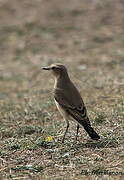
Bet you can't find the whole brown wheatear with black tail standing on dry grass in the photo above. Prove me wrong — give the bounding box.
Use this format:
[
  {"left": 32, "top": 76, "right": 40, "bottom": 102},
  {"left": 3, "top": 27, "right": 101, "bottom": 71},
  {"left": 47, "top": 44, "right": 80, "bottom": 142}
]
[{"left": 42, "top": 63, "right": 100, "bottom": 142}]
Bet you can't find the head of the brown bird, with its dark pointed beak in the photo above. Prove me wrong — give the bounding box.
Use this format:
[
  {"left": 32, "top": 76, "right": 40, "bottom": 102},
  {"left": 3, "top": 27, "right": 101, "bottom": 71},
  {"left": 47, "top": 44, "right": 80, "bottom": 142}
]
[{"left": 42, "top": 63, "right": 67, "bottom": 77}]
